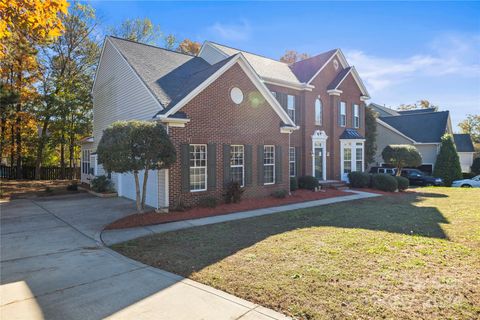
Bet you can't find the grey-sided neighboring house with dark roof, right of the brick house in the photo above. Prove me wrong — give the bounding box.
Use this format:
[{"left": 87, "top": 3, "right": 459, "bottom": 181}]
[{"left": 369, "top": 103, "right": 473, "bottom": 173}]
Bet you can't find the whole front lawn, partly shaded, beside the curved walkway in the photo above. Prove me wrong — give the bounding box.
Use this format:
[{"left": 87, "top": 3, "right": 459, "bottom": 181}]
[{"left": 113, "top": 188, "right": 480, "bottom": 319}]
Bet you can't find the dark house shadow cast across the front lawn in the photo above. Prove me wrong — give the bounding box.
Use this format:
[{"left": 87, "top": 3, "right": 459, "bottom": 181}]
[{"left": 113, "top": 193, "right": 448, "bottom": 276}]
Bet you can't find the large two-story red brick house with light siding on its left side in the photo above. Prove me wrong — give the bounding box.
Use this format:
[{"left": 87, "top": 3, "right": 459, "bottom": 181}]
[{"left": 82, "top": 37, "right": 369, "bottom": 208}]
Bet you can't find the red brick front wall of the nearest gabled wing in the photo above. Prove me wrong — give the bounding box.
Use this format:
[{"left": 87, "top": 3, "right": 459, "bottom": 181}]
[{"left": 169, "top": 64, "right": 289, "bottom": 206}]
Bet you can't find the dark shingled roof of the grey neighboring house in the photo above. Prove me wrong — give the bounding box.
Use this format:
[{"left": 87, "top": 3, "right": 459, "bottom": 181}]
[{"left": 379, "top": 111, "right": 449, "bottom": 143}]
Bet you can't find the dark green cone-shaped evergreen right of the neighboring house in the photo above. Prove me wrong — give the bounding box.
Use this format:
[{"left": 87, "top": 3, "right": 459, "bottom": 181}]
[{"left": 433, "top": 134, "right": 463, "bottom": 187}]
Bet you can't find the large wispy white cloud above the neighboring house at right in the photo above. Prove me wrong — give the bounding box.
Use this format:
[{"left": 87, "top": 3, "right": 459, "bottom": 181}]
[{"left": 345, "top": 34, "right": 480, "bottom": 94}]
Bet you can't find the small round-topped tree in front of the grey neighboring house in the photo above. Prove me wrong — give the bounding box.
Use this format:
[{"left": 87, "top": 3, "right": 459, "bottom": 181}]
[{"left": 382, "top": 144, "right": 422, "bottom": 176}]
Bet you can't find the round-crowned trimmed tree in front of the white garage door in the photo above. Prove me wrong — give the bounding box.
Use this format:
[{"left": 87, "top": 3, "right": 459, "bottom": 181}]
[{"left": 97, "top": 121, "right": 176, "bottom": 212}]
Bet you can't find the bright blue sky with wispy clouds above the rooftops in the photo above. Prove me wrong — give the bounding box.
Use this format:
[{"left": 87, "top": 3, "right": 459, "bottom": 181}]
[{"left": 88, "top": 1, "right": 480, "bottom": 130}]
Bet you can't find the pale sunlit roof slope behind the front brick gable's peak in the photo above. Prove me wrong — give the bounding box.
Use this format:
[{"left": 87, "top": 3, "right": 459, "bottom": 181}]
[{"left": 206, "top": 41, "right": 302, "bottom": 85}]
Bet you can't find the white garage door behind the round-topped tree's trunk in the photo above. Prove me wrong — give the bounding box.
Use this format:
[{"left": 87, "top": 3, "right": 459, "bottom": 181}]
[{"left": 117, "top": 170, "right": 159, "bottom": 208}]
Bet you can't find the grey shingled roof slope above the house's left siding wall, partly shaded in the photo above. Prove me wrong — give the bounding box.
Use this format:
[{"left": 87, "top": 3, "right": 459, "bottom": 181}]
[{"left": 107, "top": 36, "right": 211, "bottom": 108}]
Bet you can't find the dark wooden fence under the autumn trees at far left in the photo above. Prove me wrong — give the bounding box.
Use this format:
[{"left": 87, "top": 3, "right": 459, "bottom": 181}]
[{"left": 0, "top": 166, "right": 80, "bottom": 180}]
